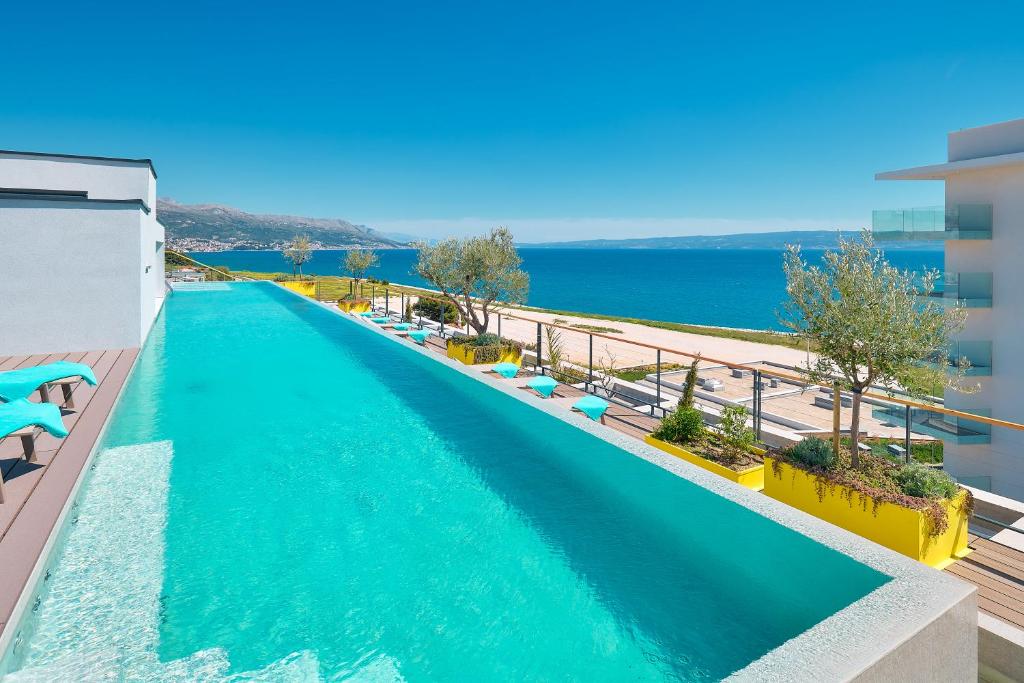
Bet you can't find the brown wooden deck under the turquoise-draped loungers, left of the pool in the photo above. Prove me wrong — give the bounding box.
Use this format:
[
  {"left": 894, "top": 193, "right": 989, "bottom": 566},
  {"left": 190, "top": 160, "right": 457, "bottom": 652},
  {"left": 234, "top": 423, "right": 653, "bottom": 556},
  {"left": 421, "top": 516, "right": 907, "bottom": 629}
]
[{"left": 0, "top": 349, "right": 138, "bottom": 632}]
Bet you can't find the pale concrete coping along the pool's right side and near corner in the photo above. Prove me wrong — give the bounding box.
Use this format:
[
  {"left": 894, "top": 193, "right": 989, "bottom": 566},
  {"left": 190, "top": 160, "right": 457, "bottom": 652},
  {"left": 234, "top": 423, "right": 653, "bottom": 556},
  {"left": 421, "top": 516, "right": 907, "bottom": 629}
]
[{"left": 299, "top": 286, "right": 978, "bottom": 681}]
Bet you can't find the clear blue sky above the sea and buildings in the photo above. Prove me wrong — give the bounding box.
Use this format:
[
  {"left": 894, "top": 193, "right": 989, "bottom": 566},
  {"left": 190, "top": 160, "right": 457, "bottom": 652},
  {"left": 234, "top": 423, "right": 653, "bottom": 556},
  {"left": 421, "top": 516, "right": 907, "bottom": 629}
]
[{"left": 0, "top": 0, "right": 1024, "bottom": 241}]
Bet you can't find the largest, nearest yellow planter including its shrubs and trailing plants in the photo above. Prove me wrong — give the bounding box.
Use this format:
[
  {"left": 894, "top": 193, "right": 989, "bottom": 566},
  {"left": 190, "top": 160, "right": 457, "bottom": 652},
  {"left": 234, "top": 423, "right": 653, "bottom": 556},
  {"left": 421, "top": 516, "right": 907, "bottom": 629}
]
[{"left": 764, "top": 437, "right": 974, "bottom": 569}]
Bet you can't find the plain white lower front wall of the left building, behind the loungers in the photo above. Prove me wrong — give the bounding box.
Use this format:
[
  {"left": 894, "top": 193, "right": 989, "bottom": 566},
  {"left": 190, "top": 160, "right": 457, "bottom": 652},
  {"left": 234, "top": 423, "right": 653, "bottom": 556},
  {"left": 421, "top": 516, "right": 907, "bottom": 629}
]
[{"left": 0, "top": 199, "right": 146, "bottom": 355}]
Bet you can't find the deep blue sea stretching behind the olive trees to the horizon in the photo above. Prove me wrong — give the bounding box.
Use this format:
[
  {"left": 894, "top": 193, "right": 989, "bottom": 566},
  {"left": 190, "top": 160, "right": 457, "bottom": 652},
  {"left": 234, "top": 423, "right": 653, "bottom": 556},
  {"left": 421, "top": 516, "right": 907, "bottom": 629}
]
[{"left": 188, "top": 248, "right": 943, "bottom": 330}]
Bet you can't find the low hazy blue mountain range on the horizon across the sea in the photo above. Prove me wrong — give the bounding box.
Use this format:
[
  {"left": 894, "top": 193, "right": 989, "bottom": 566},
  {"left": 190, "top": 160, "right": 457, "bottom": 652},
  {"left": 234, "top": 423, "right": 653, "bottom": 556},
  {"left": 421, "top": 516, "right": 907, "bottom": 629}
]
[{"left": 519, "top": 230, "right": 942, "bottom": 251}]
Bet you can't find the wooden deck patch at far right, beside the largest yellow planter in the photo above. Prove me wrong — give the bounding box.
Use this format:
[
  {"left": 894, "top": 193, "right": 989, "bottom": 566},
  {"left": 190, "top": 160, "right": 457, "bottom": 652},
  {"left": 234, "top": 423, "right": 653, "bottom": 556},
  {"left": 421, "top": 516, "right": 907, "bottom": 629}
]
[{"left": 946, "top": 533, "right": 1024, "bottom": 629}]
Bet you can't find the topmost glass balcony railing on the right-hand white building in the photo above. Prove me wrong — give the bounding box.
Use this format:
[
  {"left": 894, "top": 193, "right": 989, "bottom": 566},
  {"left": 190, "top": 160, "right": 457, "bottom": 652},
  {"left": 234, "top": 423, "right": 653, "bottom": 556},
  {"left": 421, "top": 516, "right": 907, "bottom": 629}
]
[{"left": 871, "top": 204, "right": 992, "bottom": 240}]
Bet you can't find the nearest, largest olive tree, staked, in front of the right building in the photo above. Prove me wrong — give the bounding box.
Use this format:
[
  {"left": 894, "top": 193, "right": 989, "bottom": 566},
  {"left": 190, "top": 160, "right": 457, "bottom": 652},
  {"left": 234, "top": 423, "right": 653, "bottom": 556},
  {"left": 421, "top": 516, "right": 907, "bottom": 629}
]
[{"left": 780, "top": 230, "right": 968, "bottom": 467}]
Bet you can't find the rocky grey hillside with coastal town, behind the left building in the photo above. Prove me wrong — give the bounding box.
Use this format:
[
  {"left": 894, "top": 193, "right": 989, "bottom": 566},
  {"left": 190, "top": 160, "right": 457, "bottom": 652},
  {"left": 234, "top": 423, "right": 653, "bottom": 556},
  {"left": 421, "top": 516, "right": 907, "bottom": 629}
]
[{"left": 157, "top": 199, "right": 402, "bottom": 251}]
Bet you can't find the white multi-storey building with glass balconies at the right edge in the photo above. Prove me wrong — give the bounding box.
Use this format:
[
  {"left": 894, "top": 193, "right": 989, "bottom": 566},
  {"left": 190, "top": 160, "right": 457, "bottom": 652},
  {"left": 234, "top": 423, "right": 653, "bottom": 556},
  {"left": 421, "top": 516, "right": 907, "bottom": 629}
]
[{"left": 873, "top": 119, "right": 1024, "bottom": 500}]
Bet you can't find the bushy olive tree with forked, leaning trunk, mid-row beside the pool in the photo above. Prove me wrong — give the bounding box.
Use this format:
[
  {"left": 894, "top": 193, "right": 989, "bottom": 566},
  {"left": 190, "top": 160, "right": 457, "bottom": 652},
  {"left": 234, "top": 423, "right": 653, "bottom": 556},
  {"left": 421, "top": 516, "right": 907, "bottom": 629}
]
[{"left": 415, "top": 227, "right": 529, "bottom": 335}]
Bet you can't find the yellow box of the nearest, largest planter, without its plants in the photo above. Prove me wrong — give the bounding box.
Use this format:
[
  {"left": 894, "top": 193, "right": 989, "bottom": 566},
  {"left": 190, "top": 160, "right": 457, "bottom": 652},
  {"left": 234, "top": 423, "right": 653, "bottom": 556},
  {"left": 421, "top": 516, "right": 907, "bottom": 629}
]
[{"left": 765, "top": 458, "right": 970, "bottom": 569}]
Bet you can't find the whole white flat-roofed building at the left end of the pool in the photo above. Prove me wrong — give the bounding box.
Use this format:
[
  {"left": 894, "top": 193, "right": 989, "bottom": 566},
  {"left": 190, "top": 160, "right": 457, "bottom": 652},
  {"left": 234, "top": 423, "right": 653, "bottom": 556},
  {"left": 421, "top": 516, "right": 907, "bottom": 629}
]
[{"left": 0, "top": 152, "right": 165, "bottom": 355}]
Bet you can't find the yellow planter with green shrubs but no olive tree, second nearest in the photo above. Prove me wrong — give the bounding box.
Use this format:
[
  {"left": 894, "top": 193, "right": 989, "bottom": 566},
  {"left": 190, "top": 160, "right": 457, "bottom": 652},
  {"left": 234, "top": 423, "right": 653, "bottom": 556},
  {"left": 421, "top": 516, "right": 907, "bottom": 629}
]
[{"left": 644, "top": 405, "right": 765, "bottom": 490}]
